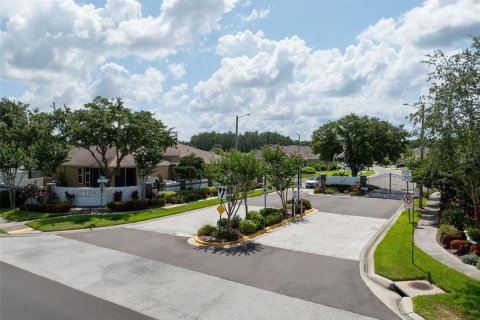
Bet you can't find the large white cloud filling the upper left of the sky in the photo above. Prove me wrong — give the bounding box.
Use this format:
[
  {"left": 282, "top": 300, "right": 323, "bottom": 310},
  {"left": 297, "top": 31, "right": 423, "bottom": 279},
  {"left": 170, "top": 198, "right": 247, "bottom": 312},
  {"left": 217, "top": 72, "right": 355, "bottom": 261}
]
[{"left": 0, "top": 0, "right": 237, "bottom": 105}]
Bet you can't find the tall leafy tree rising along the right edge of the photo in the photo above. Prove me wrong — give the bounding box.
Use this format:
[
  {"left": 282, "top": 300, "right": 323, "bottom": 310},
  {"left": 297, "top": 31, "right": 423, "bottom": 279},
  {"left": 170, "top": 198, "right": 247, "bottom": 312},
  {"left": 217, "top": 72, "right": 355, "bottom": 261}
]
[{"left": 411, "top": 36, "right": 480, "bottom": 225}]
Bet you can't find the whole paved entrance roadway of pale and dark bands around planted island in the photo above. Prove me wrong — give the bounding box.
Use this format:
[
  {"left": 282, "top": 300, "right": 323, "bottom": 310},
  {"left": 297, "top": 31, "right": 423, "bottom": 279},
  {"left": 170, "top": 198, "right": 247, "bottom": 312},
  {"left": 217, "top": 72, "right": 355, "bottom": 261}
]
[{"left": 0, "top": 195, "right": 400, "bottom": 319}]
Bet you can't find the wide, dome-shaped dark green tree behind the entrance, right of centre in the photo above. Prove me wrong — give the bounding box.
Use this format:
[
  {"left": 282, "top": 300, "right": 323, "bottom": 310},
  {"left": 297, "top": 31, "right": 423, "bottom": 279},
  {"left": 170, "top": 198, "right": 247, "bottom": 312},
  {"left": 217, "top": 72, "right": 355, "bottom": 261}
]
[{"left": 311, "top": 113, "right": 409, "bottom": 177}]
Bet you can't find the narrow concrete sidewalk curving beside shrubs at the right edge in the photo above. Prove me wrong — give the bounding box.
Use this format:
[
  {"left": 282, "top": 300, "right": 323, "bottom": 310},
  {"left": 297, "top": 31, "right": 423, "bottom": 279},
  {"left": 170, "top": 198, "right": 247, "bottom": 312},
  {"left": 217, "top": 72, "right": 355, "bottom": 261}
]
[{"left": 415, "top": 193, "right": 480, "bottom": 280}]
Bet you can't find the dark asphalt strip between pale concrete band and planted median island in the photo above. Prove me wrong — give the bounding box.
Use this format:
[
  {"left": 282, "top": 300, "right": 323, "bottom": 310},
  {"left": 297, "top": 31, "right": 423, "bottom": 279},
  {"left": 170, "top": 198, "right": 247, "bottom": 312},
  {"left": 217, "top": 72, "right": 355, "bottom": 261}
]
[{"left": 64, "top": 228, "right": 397, "bottom": 319}]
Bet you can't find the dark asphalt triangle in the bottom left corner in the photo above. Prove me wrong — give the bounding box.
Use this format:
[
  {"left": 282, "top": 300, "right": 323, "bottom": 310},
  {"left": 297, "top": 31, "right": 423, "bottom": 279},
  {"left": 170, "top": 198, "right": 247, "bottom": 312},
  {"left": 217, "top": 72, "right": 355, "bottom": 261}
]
[{"left": 0, "top": 262, "right": 152, "bottom": 320}]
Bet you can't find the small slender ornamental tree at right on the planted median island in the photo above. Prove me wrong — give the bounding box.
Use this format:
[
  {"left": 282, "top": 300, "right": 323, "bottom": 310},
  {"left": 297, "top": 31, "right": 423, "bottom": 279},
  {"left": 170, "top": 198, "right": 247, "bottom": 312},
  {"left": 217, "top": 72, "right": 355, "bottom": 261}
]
[{"left": 262, "top": 145, "right": 304, "bottom": 209}]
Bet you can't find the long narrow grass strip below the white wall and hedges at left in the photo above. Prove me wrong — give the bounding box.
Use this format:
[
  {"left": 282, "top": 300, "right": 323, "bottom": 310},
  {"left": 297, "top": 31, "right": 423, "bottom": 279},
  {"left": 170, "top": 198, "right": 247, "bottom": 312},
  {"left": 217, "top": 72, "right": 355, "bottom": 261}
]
[{"left": 27, "top": 190, "right": 262, "bottom": 232}]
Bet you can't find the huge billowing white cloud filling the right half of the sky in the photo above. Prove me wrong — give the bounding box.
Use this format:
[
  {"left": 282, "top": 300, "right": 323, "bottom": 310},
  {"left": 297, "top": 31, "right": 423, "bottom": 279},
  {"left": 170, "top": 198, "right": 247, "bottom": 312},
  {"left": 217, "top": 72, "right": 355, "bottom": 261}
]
[{"left": 190, "top": 0, "right": 480, "bottom": 136}]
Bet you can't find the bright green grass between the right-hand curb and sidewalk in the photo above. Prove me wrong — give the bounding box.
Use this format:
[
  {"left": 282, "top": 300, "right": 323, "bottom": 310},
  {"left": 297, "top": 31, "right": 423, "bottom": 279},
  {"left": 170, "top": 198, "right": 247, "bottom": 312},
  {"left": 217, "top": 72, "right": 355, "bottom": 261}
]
[{"left": 374, "top": 210, "right": 480, "bottom": 320}]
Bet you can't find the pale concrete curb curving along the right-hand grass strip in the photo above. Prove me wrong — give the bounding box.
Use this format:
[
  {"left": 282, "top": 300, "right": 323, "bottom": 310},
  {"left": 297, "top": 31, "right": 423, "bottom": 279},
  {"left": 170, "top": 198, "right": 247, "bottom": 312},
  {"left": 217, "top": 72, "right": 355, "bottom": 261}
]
[{"left": 359, "top": 204, "right": 425, "bottom": 320}]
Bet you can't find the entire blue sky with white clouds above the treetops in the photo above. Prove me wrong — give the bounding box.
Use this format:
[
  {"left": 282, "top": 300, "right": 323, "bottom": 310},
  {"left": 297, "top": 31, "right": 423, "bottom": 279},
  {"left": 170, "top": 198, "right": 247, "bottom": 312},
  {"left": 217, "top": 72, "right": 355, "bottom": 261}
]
[{"left": 0, "top": 0, "right": 480, "bottom": 140}]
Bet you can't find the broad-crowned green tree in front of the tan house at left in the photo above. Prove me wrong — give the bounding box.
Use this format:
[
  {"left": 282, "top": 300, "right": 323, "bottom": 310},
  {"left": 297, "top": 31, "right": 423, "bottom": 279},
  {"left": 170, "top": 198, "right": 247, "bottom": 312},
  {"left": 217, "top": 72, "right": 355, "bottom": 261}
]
[{"left": 65, "top": 97, "right": 177, "bottom": 183}]
